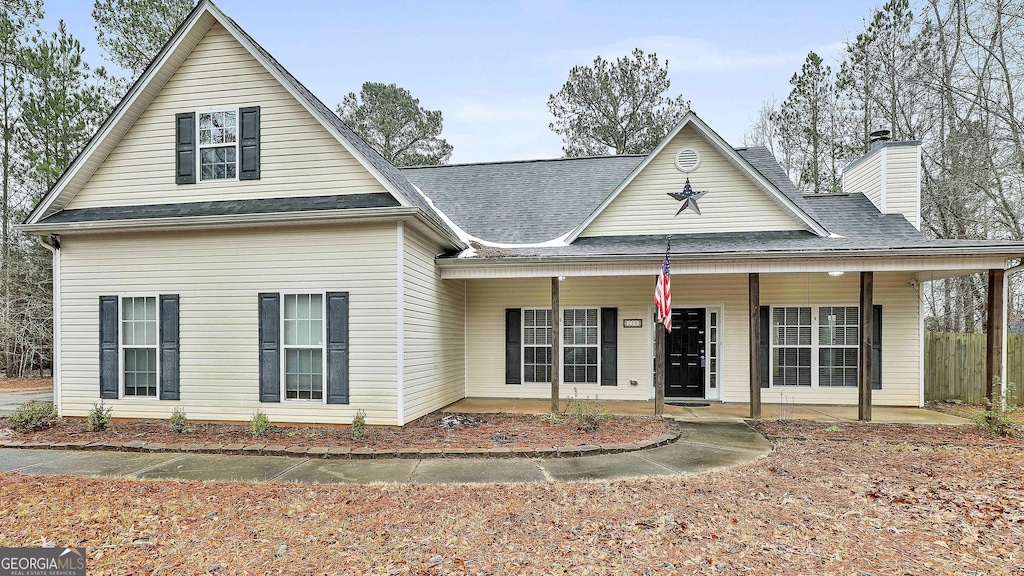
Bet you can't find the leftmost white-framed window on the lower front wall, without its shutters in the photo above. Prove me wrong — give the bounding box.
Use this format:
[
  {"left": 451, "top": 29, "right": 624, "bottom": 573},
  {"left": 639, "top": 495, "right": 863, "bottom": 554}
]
[{"left": 121, "top": 296, "right": 157, "bottom": 398}]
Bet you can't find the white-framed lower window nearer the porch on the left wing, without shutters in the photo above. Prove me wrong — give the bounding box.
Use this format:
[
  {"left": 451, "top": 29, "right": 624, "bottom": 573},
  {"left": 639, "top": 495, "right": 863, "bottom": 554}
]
[{"left": 282, "top": 294, "right": 324, "bottom": 400}]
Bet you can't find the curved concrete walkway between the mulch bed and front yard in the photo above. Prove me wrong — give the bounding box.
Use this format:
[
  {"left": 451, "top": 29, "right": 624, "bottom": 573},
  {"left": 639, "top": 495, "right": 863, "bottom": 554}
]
[{"left": 0, "top": 421, "right": 771, "bottom": 484}]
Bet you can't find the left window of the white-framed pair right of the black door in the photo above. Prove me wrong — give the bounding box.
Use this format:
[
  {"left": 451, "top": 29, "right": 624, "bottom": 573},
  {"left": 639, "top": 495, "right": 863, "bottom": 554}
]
[{"left": 772, "top": 306, "right": 811, "bottom": 386}]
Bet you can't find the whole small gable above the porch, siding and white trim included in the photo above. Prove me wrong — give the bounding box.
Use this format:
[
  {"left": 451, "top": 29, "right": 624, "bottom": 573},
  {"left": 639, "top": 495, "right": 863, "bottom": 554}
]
[{"left": 567, "top": 112, "right": 828, "bottom": 242}]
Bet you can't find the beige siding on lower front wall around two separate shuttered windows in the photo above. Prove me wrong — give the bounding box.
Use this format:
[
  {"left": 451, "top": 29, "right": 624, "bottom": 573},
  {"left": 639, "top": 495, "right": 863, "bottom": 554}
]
[{"left": 60, "top": 224, "right": 397, "bottom": 424}]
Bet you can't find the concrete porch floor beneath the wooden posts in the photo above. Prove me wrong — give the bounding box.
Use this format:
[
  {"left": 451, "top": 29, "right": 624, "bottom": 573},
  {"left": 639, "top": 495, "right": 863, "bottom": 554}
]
[{"left": 442, "top": 398, "right": 971, "bottom": 424}]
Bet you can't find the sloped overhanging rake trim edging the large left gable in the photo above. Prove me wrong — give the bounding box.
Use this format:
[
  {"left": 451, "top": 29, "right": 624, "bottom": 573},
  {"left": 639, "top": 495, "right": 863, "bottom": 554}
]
[{"left": 26, "top": 0, "right": 462, "bottom": 246}]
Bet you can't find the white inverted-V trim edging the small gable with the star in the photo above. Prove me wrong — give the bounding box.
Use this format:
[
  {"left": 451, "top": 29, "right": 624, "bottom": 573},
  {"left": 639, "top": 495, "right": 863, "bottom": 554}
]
[{"left": 566, "top": 110, "right": 828, "bottom": 243}]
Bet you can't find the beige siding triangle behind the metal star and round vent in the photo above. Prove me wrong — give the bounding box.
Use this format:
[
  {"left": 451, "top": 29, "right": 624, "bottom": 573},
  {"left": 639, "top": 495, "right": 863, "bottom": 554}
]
[{"left": 581, "top": 126, "right": 805, "bottom": 237}]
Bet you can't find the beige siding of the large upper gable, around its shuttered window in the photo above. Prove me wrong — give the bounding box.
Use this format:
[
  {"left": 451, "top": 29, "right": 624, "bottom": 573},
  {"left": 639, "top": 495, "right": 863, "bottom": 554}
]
[{"left": 68, "top": 24, "right": 384, "bottom": 208}]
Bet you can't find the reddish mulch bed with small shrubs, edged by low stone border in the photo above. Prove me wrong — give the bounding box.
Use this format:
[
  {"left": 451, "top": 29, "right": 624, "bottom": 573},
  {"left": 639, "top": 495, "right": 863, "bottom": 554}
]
[{"left": 0, "top": 413, "right": 670, "bottom": 450}]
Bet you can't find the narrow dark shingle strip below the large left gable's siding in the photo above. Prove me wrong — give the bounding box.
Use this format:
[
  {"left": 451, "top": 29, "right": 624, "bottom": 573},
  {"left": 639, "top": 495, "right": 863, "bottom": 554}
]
[{"left": 40, "top": 192, "right": 399, "bottom": 224}]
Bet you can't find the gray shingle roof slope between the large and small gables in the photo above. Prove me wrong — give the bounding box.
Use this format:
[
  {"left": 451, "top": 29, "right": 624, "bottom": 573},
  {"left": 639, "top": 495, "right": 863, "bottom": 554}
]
[{"left": 402, "top": 156, "right": 644, "bottom": 244}]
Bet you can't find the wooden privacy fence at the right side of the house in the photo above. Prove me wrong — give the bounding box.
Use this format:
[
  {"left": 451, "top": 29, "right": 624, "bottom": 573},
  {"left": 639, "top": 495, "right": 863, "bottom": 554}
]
[{"left": 925, "top": 332, "right": 1024, "bottom": 405}]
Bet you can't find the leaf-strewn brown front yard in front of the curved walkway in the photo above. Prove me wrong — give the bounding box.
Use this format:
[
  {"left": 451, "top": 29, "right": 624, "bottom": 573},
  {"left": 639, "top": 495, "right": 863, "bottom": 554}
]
[{"left": 0, "top": 422, "right": 1024, "bottom": 575}]
